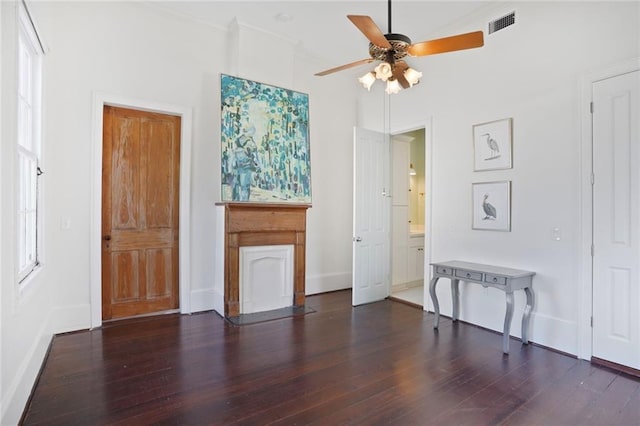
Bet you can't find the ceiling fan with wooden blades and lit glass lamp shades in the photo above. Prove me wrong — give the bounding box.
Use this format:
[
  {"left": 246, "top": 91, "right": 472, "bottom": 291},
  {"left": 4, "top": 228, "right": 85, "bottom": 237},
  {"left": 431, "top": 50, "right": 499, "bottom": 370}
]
[{"left": 315, "top": 0, "right": 484, "bottom": 93}]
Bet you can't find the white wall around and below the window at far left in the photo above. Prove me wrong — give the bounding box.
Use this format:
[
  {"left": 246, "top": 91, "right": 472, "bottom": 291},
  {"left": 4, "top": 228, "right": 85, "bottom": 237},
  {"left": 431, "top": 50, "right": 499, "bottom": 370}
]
[{"left": 0, "top": 2, "right": 52, "bottom": 424}]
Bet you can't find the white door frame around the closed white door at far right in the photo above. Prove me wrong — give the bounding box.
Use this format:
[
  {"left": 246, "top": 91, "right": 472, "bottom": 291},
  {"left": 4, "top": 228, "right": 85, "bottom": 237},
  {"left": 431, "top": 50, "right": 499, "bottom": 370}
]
[{"left": 578, "top": 58, "right": 640, "bottom": 360}]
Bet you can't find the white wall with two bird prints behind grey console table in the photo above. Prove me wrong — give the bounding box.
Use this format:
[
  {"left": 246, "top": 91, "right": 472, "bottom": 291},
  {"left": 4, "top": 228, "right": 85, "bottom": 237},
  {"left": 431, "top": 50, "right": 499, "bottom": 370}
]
[{"left": 361, "top": 2, "right": 640, "bottom": 354}]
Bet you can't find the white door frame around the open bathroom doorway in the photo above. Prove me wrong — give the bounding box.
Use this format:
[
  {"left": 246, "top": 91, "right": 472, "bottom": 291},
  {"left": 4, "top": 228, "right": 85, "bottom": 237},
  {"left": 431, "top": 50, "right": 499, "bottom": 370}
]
[{"left": 389, "top": 117, "right": 433, "bottom": 312}]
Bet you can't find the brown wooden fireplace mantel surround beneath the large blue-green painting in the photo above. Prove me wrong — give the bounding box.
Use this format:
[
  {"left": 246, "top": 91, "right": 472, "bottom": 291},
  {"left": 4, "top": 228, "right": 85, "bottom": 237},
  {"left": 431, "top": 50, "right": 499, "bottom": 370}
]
[{"left": 216, "top": 203, "right": 311, "bottom": 317}]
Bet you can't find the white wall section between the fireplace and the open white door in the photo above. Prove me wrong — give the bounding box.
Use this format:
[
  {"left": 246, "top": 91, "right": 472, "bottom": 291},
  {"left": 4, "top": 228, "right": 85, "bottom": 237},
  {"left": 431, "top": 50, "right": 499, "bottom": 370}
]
[{"left": 294, "top": 50, "right": 360, "bottom": 294}]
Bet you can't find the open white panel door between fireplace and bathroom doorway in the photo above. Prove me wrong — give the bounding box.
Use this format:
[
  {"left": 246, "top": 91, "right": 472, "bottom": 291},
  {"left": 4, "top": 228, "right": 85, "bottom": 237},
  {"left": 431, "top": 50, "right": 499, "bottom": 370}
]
[{"left": 352, "top": 128, "right": 391, "bottom": 306}]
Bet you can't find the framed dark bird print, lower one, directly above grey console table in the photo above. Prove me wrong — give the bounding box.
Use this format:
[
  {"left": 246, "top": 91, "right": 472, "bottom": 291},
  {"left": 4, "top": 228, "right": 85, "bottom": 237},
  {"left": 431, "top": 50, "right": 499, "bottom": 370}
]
[{"left": 471, "top": 180, "right": 511, "bottom": 232}]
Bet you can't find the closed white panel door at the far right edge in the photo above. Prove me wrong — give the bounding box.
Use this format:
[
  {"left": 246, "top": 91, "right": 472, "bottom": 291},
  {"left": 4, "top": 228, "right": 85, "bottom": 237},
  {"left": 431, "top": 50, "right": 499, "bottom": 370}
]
[{"left": 593, "top": 71, "right": 640, "bottom": 369}]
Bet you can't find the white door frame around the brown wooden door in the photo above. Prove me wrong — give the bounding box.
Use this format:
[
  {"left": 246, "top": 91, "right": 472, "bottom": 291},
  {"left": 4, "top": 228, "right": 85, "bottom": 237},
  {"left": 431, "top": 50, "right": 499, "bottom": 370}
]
[{"left": 89, "top": 92, "right": 193, "bottom": 328}]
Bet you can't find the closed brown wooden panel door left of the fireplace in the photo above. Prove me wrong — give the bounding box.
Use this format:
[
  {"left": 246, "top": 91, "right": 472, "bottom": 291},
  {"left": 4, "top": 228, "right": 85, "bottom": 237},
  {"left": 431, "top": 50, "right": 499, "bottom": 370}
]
[{"left": 102, "top": 106, "right": 180, "bottom": 320}]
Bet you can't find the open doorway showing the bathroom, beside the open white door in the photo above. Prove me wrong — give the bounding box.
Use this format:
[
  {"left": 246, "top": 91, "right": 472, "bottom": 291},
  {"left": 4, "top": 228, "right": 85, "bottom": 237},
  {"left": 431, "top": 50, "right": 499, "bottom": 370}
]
[{"left": 391, "top": 128, "right": 429, "bottom": 308}]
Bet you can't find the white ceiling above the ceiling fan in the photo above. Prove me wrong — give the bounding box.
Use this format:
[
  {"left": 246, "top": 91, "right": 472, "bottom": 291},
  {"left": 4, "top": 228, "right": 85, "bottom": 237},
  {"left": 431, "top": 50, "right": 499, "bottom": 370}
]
[{"left": 150, "top": 0, "right": 494, "bottom": 71}]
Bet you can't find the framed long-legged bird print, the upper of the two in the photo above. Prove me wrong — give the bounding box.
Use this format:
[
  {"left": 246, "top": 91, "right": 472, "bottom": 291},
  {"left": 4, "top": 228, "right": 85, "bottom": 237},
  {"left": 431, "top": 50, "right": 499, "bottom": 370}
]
[{"left": 473, "top": 118, "right": 513, "bottom": 172}]
